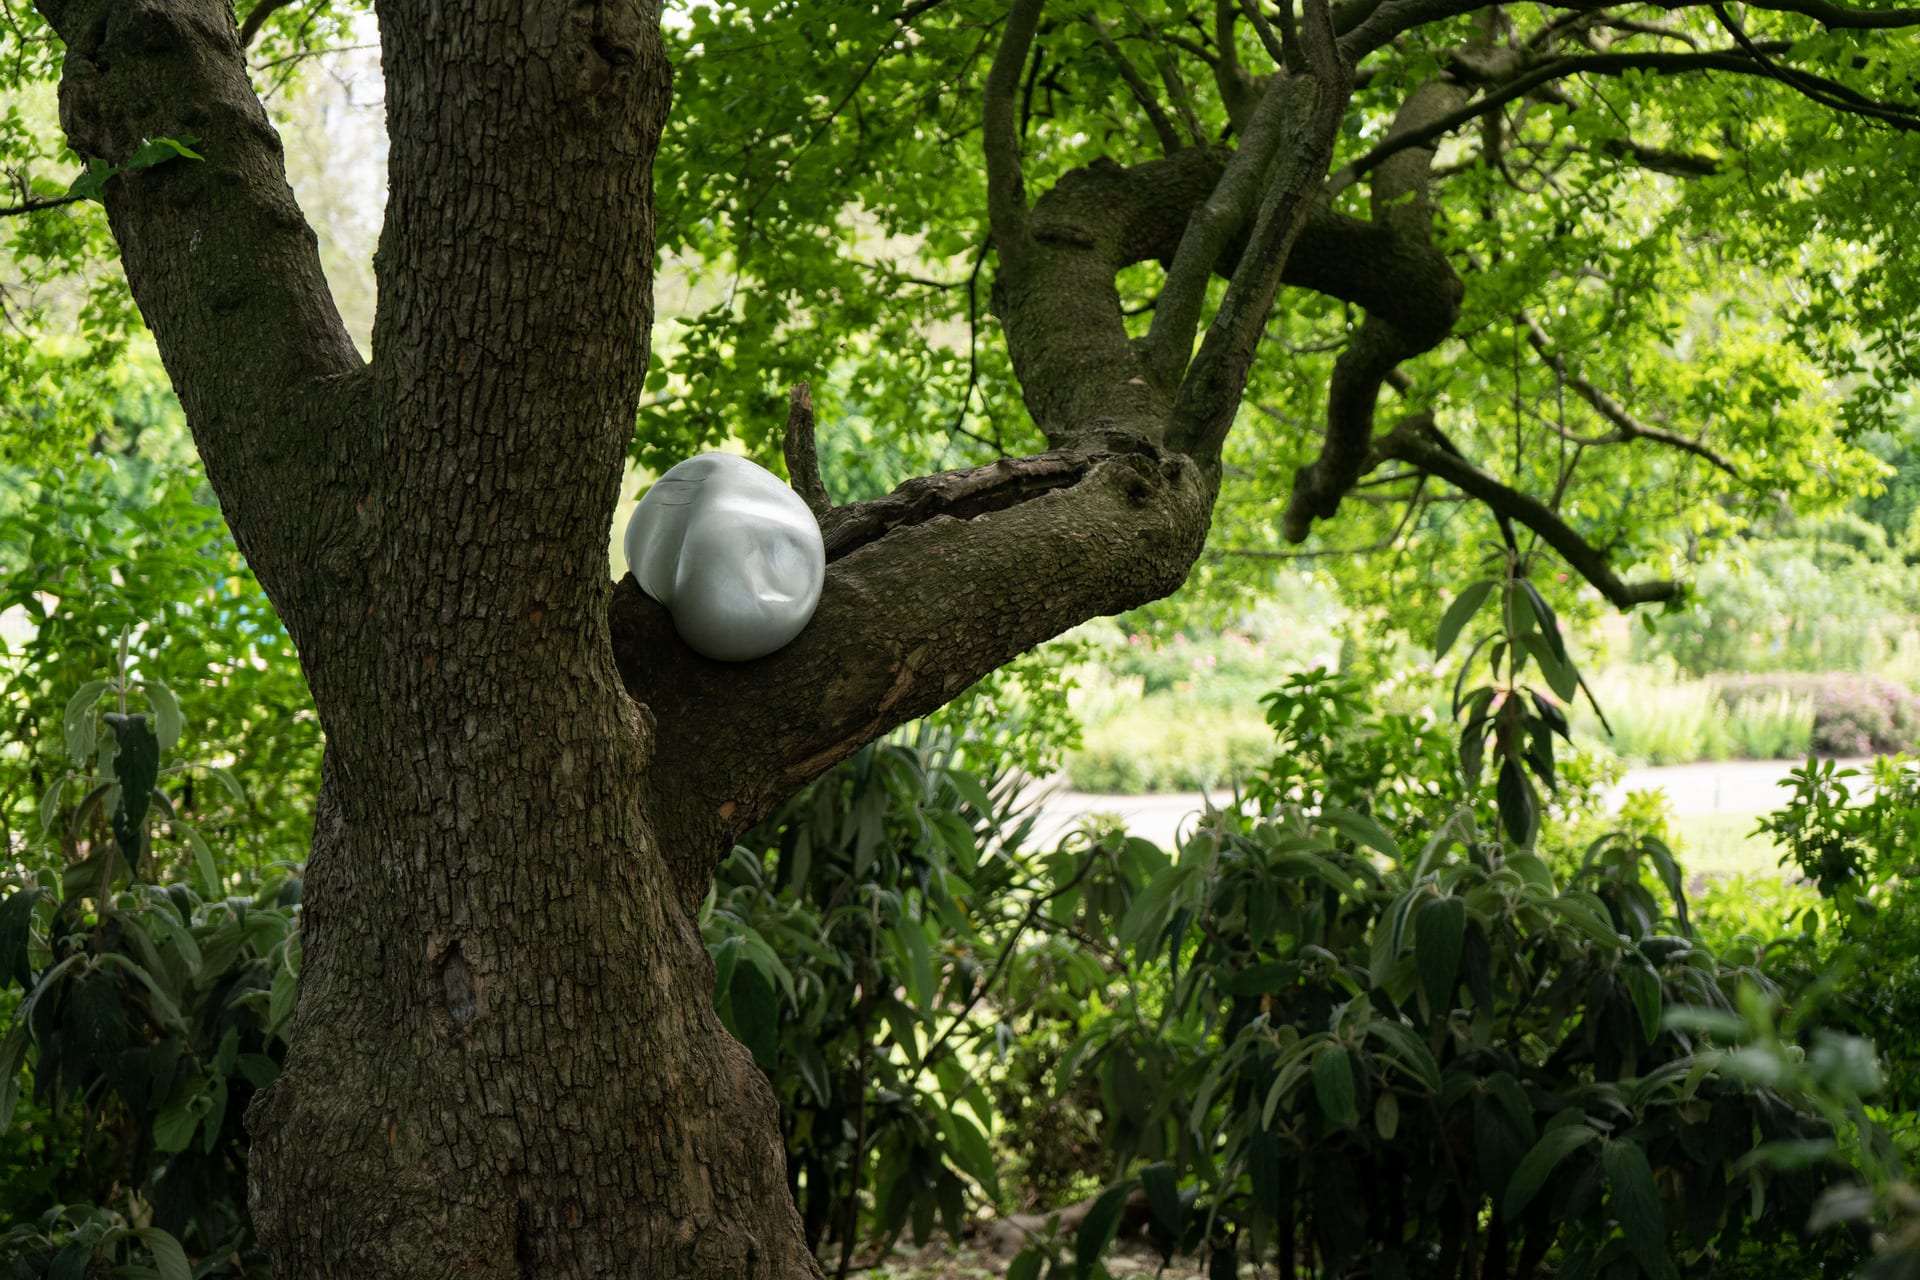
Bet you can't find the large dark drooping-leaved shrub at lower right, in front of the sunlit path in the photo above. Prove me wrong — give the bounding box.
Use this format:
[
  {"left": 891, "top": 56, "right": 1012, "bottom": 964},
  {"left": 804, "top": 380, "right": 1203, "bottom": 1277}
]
[{"left": 1013, "top": 677, "right": 1845, "bottom": 1276}]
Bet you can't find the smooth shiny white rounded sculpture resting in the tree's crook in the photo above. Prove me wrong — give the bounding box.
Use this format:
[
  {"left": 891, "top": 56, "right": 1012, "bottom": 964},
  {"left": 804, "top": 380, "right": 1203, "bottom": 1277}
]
[{"left": 626, "top": 453, "right": 828, "bottom": 662}]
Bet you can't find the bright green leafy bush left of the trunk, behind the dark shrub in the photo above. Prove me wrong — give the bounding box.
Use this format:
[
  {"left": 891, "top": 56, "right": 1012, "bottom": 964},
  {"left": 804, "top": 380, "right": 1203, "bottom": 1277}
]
[{"left": 0, "top": 435, "right": 321, "bottom": 867}]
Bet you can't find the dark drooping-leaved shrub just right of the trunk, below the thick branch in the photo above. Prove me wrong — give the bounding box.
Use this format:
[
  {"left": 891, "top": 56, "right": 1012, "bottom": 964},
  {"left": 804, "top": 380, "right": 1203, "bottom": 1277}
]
[{"left": 703, "top": 733, "right": 1033, "bottom": 1255}]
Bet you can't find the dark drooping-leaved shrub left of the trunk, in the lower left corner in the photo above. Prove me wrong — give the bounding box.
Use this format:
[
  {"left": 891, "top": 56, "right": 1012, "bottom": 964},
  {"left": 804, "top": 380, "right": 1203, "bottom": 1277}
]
[{"left": 0, "top": 649, "right": 300, "bottom": 1278}]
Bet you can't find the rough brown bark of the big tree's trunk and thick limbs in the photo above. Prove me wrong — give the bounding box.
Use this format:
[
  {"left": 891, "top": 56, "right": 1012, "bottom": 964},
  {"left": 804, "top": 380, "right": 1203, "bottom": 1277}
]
[{"left": 22, "top": 0, "right": 1689, "bottom": 1280}]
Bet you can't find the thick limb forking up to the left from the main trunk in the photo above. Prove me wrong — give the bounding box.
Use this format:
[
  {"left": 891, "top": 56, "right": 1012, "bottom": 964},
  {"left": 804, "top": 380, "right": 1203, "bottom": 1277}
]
[{"left": 40, "top": 0, "right": 361, "bottom": 580}]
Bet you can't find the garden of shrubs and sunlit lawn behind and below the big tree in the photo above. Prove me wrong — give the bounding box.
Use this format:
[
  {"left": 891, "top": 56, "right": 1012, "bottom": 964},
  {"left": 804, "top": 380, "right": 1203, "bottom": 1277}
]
[{"left": 0, "top": 2, "right": 1920, "bottom": 1280}]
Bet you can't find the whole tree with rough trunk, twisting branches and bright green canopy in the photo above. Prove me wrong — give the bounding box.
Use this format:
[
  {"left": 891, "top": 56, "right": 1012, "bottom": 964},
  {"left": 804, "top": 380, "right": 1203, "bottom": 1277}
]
[{"left": 0, "top": 0, "right": 1920, "bottom": 1278}]
